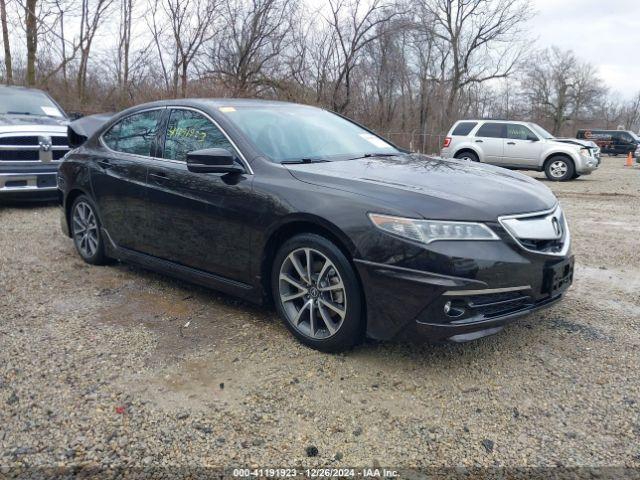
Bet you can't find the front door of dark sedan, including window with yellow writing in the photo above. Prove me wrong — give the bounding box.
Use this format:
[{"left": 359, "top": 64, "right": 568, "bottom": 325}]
[{"left": 147, "top": 108, "right": 252, "bottom": 283}]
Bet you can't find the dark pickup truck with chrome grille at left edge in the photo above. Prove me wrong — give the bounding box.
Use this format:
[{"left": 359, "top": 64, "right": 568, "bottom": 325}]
[{"left": 0, "top": 86, "right": 69, "bottom": 201}]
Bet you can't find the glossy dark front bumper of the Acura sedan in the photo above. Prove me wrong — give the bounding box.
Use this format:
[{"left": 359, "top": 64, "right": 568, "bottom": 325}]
[{"left": 355, "top": 226, "right": 573, "bottom": 342}]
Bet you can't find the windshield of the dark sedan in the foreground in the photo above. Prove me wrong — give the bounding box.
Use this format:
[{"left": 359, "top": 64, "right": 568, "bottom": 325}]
[{"left": 219, "top": 105, "right": 401, "bottom": 163}]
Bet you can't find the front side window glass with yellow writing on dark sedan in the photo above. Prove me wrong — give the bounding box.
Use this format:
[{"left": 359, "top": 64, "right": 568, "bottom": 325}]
[{"left": 163, "top": 110, "right": 235, "bottom": 162}]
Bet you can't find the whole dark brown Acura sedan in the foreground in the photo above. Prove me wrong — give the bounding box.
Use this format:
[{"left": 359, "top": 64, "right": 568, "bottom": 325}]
[{"left": 58, "top": 99, "right": 573, "bottom": 351}]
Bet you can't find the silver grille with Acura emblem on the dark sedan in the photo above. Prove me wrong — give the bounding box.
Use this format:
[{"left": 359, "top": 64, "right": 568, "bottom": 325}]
[{"left": 498, "top": 206, "right": 571, "bottom": 255}]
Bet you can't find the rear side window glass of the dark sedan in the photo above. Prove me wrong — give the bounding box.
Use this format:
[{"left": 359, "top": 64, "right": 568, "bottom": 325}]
[{"left": 102, "top": 110, "right": 163, "bottom": 157}]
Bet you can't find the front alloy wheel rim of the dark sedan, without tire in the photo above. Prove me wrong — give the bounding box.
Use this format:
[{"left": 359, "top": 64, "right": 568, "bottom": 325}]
[{"left": 278, "top": 248, "right": 347, "bottom": 339}]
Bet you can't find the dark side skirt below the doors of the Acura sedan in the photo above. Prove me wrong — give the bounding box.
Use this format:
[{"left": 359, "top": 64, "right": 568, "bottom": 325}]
[{"left": 101, "top": 228, "right": 263, "bottom": 304}]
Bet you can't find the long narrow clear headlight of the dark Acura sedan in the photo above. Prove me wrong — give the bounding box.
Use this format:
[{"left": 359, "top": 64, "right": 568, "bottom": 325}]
[{"left": 369, "top": 213, "right": 500, "bottom": 243}]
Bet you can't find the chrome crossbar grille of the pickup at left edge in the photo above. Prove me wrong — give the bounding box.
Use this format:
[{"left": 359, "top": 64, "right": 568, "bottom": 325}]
[{"left": 0, "top": 134, "right": 69, "bottom": 163}]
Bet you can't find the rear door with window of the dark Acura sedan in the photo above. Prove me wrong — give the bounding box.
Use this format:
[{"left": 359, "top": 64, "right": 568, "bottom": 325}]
[{"left": 91, "top": 108, "right": 164, "bottom": 251}]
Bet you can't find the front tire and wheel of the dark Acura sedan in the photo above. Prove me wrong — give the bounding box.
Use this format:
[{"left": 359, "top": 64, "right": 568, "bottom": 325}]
[{"left": 271, "top": 233, "right": 364, "bottom": 352}]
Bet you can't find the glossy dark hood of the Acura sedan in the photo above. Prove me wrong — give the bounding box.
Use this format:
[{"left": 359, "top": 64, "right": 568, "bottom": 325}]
[{"left": 287, "top": 154, "right": 557, "bottom": 221}]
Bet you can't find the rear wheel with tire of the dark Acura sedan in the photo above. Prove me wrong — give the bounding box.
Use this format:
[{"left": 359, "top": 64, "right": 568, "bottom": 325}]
[{"left": 69, "top": 195, "right": 109, "bottom": 265}]
